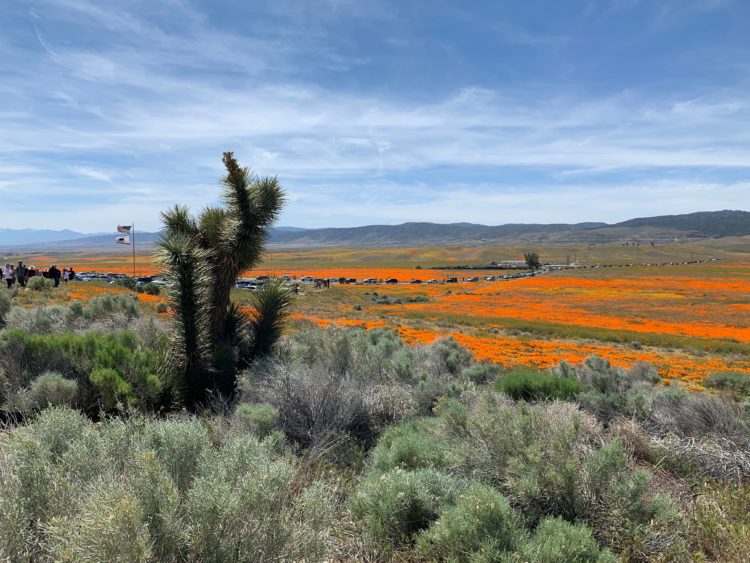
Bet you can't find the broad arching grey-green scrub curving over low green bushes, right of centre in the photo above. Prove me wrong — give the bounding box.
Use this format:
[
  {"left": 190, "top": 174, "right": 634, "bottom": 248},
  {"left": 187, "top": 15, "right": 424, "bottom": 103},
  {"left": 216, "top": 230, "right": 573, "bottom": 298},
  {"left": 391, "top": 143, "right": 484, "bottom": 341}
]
[{"left": 368, "top": 393, "right": 682, "bottom": 558}]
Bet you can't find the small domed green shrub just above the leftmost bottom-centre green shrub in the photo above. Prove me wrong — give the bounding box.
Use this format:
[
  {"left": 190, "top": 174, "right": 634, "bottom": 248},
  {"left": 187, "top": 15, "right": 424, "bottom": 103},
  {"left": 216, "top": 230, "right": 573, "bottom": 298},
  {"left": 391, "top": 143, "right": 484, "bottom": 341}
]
[{"left": 370, "top": 419, "right": 446, "bottom": 473}]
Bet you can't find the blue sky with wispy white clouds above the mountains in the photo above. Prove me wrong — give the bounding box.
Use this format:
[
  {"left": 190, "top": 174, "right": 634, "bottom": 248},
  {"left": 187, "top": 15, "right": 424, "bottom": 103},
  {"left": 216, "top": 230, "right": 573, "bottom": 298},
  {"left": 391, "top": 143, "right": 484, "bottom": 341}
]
[{"left": 0, "top": 0, "right": 750, "bottom": 232}]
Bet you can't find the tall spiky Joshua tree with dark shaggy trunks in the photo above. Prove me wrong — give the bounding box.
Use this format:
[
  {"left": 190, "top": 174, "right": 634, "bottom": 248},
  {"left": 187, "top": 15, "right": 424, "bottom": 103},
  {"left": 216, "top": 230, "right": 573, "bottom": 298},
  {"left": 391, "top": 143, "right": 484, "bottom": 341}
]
[{"left": 157, "top": 152, "right": 290, "bottom": 408}]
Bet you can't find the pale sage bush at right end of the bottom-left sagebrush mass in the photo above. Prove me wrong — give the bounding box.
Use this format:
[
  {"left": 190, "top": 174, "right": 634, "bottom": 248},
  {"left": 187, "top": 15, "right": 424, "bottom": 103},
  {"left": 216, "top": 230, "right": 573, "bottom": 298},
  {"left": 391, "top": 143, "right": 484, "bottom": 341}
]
[{"left": 186, "top": 435, "right": 333, "bottom": 561}]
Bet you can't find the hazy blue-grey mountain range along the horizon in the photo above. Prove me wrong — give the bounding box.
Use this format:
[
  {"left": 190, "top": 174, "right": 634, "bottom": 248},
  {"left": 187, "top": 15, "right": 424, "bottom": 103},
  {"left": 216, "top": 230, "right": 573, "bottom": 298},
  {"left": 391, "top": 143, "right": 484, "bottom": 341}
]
[{"left": 0, "top": 210, "right": 750, "bottom": 252}]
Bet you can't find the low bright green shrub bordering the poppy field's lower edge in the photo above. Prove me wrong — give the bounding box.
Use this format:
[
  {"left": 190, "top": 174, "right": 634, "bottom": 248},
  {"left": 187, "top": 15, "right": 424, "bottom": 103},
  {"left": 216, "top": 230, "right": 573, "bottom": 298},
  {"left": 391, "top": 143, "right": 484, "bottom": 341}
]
[{"left": 495, "top": 368, "right": 583, "bottom": 401}]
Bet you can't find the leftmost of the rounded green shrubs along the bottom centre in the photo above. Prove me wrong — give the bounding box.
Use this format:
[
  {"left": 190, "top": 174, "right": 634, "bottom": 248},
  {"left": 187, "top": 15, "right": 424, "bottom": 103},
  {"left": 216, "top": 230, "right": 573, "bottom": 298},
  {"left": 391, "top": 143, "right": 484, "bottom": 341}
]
[{"left": 351, "top": 469, "right": 466, "bottom": 550}]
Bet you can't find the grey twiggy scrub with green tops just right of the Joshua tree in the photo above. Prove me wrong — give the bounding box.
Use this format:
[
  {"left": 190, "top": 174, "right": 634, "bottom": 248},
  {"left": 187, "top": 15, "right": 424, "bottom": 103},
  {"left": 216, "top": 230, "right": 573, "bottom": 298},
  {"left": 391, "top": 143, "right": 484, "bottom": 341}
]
[{"left": 253, "top": 328, "right": 473, "bottom": 449}]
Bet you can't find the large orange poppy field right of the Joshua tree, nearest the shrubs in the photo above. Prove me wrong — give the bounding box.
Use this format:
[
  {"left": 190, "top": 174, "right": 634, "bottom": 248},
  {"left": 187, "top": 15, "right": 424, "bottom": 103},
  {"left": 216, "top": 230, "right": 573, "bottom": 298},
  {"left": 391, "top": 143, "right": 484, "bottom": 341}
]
[{"left": 270, "top": 263, "right": 750, "bottom": 389}]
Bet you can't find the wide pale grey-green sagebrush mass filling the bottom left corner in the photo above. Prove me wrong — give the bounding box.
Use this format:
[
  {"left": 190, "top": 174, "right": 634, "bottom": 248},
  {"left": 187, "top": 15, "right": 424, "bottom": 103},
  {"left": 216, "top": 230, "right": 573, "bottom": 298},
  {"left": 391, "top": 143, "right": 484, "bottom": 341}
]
[{"left": 0, "top": 408, "right": 335, "bottom": 561}]
